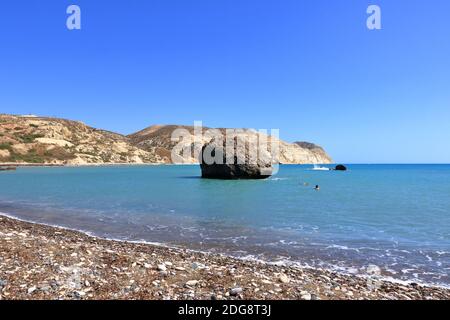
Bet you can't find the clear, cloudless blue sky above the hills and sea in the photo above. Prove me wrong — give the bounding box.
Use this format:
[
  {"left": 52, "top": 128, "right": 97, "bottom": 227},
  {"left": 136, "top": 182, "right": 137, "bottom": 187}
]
[{"left": 0, "top": 0, "right": 450, "bottom": 163}]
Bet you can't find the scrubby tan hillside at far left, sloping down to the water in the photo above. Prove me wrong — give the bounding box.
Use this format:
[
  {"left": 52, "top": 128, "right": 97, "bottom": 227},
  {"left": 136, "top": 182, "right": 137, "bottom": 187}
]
[{"left": 0, "top": 115, "right": 161, "bottom": 165}]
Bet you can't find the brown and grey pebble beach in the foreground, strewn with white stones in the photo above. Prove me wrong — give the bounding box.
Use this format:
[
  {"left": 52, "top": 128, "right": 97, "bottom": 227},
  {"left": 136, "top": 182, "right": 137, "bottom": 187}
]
[{"left": 0, "top": 214, "right": 450, "bottom": 300}]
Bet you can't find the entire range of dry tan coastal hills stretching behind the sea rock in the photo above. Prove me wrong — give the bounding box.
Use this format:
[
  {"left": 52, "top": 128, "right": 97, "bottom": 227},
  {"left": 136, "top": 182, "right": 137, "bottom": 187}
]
[{"left": 0, "top": 114, "right": 332, "bottom": 165}]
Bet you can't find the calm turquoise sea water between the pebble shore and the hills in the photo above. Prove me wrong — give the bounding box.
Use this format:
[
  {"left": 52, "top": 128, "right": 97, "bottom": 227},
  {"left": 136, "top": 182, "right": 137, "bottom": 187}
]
[{"left": 0, "top": 165, "right": 450, "bottom": 286}]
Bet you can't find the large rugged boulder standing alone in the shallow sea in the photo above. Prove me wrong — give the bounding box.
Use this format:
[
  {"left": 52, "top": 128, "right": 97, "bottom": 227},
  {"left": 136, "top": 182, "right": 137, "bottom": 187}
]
[{"left": 199, "top": 135, "right": 273, "bottom": 179}]
